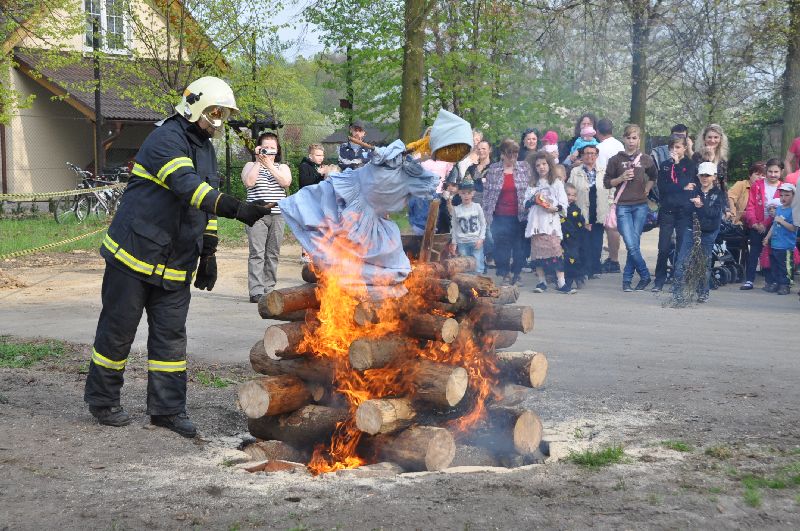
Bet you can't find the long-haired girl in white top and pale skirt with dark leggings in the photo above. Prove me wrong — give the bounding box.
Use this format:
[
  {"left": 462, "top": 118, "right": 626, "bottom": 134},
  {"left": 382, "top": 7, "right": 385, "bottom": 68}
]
[{"left": 525, "top": 152, "right": 575, "bottom": 293}]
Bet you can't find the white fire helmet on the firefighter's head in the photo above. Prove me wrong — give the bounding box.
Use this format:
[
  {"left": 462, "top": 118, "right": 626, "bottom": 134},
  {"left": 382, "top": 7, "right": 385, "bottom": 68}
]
[{"left": 175, "top": 76, "right": 239, "bottom": 137}]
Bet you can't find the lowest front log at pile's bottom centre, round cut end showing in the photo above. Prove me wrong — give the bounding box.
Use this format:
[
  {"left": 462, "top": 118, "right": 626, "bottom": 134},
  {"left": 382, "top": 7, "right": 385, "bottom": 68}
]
[{"left": 370, "top": 426, "right": 456, "bottom": 471}]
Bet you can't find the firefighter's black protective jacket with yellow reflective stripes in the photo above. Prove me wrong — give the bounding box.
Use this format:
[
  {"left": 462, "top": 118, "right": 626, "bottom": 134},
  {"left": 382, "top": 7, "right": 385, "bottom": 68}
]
[{"left": 100, "top": 115, "right": 225, "bottom": 290}]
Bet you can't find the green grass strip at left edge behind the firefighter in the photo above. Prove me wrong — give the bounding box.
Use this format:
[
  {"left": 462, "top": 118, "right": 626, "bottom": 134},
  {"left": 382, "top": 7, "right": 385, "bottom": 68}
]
[{"left": 0, "top": 213, "right": 106, "bottom": 255}]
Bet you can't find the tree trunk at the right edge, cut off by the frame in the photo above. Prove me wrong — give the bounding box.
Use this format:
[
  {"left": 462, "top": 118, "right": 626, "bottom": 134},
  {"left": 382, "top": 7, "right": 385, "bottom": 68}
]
[{"left": 782, "top": 0, "right": 800, "bottom": 154}]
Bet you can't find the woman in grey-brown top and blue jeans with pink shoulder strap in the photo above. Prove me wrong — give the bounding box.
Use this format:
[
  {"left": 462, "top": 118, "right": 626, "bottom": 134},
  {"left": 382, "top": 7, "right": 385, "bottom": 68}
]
[{"left": 603, "top": 124, "right": 658, "bottom": 292}]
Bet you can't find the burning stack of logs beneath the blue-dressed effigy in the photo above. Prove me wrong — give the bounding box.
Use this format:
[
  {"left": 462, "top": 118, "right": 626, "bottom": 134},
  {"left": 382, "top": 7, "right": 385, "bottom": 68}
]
[{"left": 238, "top": 257, "right": 547, "bottom": 471}]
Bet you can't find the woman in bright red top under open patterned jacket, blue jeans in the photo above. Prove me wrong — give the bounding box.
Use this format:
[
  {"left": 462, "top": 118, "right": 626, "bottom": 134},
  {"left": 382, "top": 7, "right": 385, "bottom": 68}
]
[{"left": 483, "top": 138, "right": 531, "bottom": 284}]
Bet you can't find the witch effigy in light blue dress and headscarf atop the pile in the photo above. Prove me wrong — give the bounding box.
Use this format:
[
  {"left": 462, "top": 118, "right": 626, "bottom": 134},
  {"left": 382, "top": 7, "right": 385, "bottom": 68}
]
[{"left": 279, "top": 109, "right": 472, "bottom": 299}]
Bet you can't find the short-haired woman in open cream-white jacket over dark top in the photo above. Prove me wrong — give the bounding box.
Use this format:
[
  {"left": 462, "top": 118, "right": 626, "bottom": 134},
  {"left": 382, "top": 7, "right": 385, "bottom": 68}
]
[{"left": 567, "top": 146, "right": 614, "bottom": 278}]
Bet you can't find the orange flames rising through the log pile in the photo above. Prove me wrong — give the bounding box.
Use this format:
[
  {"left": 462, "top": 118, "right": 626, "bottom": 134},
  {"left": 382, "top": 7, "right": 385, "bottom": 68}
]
[{"left": 300, "top": 214, "right": 497, "bottom": 475}]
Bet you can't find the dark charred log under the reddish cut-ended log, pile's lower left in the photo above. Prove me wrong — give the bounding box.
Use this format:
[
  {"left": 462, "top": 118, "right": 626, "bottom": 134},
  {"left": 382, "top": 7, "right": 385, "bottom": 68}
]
[{"left": 247, "top": 404, "right": 349, "bottom": 448}]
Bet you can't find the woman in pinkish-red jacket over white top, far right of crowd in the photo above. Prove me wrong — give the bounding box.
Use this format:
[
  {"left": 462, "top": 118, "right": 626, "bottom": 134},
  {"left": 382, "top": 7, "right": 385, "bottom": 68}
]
[{"left": 739, "top": 159, "right": 783, "bottom": 290}]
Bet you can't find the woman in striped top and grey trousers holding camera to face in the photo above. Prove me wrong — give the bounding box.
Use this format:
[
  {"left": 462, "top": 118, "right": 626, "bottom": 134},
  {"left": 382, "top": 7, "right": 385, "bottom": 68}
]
[{"left": 242, "top": 132, "right": 292, "bottom": 302}]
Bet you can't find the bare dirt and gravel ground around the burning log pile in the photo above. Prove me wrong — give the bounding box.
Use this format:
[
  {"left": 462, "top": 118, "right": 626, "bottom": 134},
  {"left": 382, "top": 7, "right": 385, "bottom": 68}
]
[{"left": 0, "top": 238, "right": 800, "bottom": 529}]
